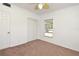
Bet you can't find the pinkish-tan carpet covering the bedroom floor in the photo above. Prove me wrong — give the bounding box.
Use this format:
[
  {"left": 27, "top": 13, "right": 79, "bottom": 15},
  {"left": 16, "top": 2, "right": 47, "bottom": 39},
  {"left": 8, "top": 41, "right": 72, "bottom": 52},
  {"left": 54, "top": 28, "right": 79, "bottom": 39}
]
[{"left": 0, "top": 40, "right": 79, "bottom": 56}]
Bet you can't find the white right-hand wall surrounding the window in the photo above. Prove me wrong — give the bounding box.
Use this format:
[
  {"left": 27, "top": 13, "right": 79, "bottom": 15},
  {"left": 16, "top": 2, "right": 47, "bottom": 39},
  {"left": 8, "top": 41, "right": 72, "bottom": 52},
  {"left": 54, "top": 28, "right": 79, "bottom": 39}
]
[{"left": 38, "top": 5, "right": 79, "bottom": 51}]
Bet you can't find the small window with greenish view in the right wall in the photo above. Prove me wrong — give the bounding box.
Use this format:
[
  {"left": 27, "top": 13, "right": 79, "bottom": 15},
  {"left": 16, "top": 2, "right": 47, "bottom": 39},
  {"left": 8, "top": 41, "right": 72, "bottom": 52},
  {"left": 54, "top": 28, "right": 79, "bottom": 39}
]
[{"left": 44, "top": 19, "right": 53, "bottom": 37}]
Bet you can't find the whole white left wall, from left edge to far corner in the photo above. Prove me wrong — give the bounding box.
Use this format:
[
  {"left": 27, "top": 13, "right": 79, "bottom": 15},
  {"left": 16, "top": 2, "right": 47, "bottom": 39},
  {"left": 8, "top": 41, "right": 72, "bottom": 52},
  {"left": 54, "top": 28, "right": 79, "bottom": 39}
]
[{"left": 0, "top": 4, "right": 38, "bottom": 49}]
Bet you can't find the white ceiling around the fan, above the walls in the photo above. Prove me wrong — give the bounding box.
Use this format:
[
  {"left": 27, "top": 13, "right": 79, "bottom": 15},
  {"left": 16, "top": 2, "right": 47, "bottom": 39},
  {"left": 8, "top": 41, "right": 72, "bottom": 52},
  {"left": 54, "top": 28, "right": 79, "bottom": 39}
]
[{"left": 15, "top": 3, "right": 79, "bottom": 15}]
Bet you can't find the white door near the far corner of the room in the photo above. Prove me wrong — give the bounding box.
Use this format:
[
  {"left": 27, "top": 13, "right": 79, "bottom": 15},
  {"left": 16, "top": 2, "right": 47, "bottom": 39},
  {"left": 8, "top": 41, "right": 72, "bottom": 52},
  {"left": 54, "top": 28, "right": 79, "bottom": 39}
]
[{"left": 27, "top": 18, "right": 37, "bottom": 41}]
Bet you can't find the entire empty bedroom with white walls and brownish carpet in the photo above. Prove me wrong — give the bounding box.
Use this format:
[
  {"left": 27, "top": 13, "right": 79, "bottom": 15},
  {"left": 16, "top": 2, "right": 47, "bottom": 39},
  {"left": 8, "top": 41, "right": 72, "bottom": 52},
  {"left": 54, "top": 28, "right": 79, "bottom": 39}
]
[{"left": 0, "top": 3, "right": 79, "bottom": 56}]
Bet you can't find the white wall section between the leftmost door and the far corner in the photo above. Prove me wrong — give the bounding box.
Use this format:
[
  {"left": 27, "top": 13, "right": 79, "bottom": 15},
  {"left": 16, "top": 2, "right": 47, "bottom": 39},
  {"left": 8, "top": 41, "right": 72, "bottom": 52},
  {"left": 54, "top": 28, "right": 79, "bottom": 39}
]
[{"left": 11, "top": 5, "right": 37, "bottom": 45}]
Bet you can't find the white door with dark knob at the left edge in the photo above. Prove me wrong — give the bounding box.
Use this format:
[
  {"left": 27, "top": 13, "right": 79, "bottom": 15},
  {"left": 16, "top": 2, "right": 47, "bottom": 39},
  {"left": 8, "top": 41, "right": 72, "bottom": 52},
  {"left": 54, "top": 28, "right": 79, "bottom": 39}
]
[{"left": 0, "top": 5, "right": 10, "bottom": 49}]
